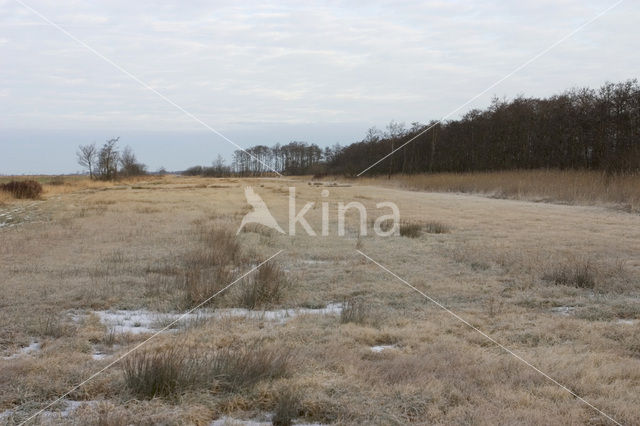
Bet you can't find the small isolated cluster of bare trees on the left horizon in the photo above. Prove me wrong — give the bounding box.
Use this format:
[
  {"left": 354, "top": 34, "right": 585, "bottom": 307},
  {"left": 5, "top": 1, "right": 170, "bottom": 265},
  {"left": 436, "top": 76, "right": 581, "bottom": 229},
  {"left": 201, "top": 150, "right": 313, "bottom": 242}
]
[{"left": 76, "top": 137, "right": 147, "bottom": 180}]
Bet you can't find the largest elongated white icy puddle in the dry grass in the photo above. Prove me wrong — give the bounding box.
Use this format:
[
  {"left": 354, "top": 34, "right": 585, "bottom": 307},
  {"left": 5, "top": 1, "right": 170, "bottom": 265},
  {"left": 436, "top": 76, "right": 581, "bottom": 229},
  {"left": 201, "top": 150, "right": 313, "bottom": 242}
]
[{"left": 93, "top": 303, "right": 342, "bottom": 332}]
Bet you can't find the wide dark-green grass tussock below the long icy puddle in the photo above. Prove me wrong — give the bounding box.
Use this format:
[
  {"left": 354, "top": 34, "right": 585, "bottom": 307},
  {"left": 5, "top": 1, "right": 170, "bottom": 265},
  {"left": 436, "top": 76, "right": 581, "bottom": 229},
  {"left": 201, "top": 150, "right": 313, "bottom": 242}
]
[{"left": 122, "top": 344, "right": 293, "bottom": 399}]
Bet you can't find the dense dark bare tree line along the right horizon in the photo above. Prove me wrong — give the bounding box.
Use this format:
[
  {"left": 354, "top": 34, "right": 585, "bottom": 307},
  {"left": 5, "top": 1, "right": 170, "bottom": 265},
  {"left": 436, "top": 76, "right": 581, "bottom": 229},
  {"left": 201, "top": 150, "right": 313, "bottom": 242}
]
[{"left": 325, "top": 79, "right": 640, "bottom": 175}]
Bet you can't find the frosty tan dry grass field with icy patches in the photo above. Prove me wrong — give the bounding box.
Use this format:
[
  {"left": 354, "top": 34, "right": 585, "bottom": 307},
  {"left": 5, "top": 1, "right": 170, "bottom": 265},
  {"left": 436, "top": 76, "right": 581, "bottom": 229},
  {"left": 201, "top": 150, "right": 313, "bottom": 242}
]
[{"left": 0, "top": 176, "right": 640, "bottom": 426}]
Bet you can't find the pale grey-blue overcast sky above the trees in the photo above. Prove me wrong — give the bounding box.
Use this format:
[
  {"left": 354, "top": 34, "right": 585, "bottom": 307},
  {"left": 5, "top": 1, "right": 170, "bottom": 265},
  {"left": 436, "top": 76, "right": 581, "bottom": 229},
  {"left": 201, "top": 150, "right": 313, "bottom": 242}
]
[{"left": 0, "top": 0, "right": 640, "bottom": 174}]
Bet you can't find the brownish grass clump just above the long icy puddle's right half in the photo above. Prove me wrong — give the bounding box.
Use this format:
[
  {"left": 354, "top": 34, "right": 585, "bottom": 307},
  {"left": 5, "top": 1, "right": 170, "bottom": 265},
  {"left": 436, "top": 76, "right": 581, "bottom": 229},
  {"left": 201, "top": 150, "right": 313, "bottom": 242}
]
[{"left": 238, "top": 262, "right": 289, "bottom": 309}]
